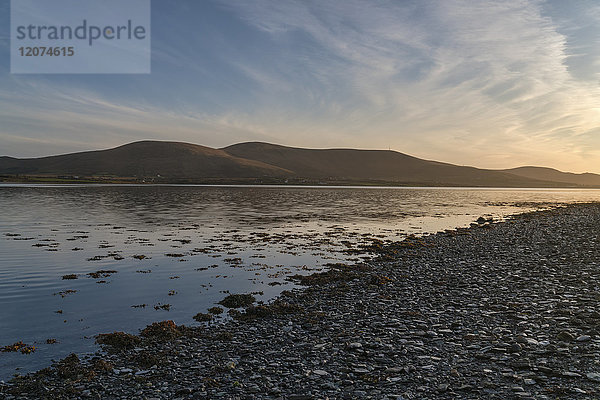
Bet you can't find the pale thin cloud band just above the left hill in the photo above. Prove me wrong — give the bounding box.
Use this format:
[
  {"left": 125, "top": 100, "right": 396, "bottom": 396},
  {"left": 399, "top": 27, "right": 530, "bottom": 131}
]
[{"left": 0, "top": 85, "right": 275, "bottom": 157}]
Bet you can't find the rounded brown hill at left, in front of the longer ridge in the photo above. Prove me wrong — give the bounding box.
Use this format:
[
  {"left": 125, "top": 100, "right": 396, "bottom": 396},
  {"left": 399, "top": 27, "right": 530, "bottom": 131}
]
[{"left": 0, "top": 141, "right": 290, "bottom": 179}]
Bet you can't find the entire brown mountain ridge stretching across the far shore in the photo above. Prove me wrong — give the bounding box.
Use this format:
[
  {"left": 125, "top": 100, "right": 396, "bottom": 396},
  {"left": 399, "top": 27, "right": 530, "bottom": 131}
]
[{"left": 0, "top": 141, "right": 600, "bottom": 187}]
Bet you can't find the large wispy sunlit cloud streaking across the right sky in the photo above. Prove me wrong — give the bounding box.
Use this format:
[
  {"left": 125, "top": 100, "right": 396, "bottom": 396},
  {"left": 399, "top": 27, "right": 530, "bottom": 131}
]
[{"left": 217, "top": 0, "right": 600, "bottom": 171}]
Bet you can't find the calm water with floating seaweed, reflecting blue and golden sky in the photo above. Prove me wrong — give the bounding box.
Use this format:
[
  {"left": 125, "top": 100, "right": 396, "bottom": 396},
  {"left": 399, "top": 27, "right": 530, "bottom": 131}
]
[{"left": 0, "top": 185, "right": 600, "bottom": 379}]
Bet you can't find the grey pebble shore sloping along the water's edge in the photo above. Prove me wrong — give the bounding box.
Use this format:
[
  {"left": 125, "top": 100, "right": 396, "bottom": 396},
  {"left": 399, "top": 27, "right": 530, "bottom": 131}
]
[{"left": 0, "top": 204, "right": 600, "bottom": 400}]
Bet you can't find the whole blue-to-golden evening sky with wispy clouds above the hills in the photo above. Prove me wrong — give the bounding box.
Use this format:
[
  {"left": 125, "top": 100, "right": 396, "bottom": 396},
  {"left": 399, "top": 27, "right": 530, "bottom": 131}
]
[{"left": 0, "top": 0, "right": 600, "bottom": 173}]
